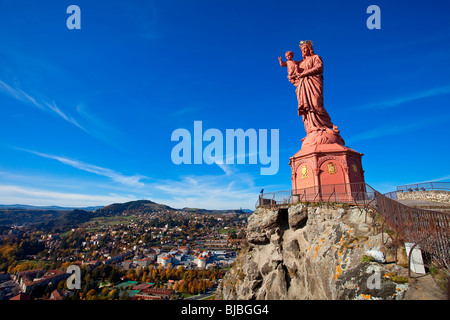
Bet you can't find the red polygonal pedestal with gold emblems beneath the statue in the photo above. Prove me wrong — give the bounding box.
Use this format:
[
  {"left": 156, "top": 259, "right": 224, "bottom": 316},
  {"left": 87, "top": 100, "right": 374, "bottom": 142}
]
[{"left": 289, "top": 143, "right": 365, "bottom": 201}]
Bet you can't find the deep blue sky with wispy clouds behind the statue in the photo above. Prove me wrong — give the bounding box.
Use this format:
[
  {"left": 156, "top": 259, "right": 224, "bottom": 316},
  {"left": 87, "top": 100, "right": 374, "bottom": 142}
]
[{"left": 0, "top": 0, "right": 450, "bottom": 209}]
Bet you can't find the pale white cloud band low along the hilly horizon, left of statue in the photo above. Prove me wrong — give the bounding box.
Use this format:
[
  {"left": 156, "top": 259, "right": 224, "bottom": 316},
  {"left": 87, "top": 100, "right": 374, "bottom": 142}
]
[{"left": 0, "top": 168, "right": 260, "bottom": 209}]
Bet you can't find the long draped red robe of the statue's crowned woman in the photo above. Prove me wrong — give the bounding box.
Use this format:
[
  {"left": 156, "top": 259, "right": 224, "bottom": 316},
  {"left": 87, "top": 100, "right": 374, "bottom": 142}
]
[{"left": 296, "top": 55, "right": 333, "bottom": 134}]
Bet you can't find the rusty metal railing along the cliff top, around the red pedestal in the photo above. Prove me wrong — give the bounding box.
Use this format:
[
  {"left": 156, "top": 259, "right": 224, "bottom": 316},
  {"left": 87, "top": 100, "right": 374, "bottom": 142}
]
[{"left": 256, "top": 183, "right": 450, "bottom": 271}]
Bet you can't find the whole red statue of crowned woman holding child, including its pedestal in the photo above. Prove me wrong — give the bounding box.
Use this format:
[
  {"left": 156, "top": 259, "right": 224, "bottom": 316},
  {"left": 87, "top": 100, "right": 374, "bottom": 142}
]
[{"left": 278, "top": 40, "right": 364, "bottom": 196}]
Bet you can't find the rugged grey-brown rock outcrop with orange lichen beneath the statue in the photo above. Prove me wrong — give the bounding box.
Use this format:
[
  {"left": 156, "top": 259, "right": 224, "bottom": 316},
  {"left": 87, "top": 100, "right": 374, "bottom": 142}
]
[{"left": 216, "top": 204, "right": 407, "bottom": 300}]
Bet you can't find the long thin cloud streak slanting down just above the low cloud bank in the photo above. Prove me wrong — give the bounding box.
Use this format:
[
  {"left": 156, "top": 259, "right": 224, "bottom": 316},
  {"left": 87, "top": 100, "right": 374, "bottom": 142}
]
[{"left": 18, "top": 149, "right": 146, "bottom": 188}]
